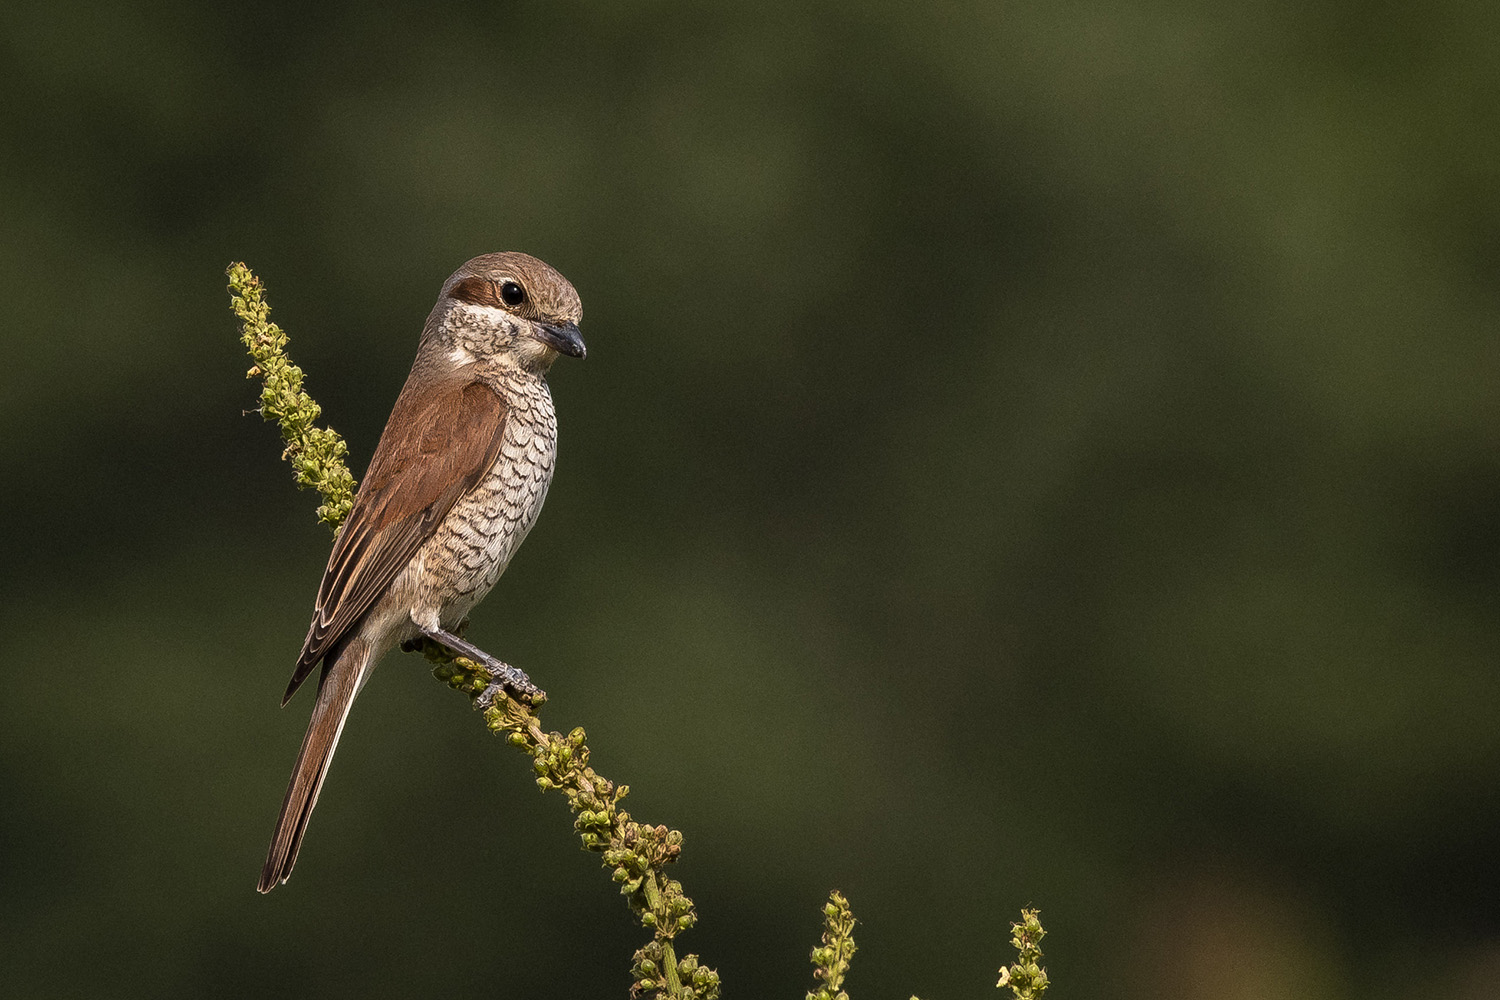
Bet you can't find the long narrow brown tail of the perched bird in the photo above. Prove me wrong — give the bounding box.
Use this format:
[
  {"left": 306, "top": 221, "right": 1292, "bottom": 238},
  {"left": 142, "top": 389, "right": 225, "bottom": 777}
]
[{"left": 257, "top": 637, "right": 371, "bottom": 892}]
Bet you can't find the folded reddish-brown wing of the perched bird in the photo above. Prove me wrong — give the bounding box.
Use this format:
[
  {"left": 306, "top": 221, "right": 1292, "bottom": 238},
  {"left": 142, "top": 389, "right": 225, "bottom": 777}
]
[{"left": 282, "top": 366, "right": 507, "bottom": 705}]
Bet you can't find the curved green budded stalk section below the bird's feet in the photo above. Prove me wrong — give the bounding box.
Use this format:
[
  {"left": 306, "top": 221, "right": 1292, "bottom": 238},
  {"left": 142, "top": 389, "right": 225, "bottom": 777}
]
[{"left": 422, "top": 653, "right": 719, "bottom": 1000}]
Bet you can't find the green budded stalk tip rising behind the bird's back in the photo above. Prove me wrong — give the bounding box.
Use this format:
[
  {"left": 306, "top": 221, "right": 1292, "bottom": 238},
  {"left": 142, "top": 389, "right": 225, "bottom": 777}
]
[{"left": 227, "top": 264, "right": 354, "bottom": 529}]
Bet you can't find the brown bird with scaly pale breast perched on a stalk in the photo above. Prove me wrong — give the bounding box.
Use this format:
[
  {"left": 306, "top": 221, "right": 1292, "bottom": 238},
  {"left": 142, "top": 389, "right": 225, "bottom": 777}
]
[{"left": 257, "top": 252, "right": 585, "bottom": 892}]
